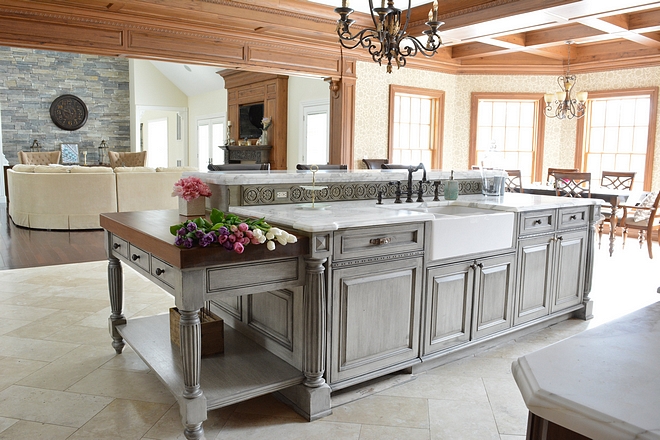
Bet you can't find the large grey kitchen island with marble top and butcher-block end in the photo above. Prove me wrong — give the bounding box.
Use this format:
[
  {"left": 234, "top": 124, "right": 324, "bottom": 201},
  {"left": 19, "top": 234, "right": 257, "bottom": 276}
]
[{"left": 102, "top": 173, "right": 599, "bottom": 438}]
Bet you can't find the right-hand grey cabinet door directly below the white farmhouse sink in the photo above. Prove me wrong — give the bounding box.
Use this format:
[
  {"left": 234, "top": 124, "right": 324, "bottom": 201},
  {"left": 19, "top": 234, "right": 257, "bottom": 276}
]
[{"left": 472, "top": 254, "right": 516, "bottom": 339}]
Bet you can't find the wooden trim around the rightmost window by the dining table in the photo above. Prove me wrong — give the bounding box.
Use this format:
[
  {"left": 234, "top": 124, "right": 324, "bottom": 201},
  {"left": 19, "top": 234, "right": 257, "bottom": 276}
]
[{"left": 575, "top": 87, "right": 658, "bottom": 191}]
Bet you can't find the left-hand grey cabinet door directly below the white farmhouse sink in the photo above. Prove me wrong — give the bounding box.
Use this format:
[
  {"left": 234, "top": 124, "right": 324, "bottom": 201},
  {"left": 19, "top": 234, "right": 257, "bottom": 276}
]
[{"left": 422, "top": 262, "right": 475, "bottom": 356}]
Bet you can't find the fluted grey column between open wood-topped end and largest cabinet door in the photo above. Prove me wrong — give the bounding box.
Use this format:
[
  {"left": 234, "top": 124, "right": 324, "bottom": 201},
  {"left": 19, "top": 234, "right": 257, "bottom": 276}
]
[{"left": 303, "top": 258, "right": 327, "bottom": 388}]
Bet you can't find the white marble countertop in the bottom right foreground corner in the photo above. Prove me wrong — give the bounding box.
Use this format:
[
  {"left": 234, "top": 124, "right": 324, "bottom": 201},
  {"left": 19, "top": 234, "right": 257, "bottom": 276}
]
[{"left": 512, "top": 302, "right": 660, "bottom": 440}]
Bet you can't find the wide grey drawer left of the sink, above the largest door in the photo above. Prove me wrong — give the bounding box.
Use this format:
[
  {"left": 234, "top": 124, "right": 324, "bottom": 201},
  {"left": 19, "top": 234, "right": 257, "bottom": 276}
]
[{"left": 334, "top": 223, "right": 424, "bottom": 260}]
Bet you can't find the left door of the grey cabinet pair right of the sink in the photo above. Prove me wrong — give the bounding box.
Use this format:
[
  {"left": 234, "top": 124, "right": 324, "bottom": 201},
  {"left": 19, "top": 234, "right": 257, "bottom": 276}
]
[{"left": 514, "top": 234, "right": 555, "bottom": 325}]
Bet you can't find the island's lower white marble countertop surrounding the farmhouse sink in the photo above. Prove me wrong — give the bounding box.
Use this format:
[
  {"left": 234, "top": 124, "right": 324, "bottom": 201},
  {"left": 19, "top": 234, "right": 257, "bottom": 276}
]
[{"left": 229, "top": 194, "right": 599, "bottom": 232}]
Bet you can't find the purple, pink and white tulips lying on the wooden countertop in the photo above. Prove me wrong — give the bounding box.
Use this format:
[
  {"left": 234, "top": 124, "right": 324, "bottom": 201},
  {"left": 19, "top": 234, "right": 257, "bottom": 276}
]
[{"left": 170, "top": 208, "right": 298, "bottom": 254}]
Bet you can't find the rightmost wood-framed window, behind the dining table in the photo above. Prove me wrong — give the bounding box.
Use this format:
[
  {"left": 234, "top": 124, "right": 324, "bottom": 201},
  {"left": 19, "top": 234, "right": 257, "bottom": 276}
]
[{"left": 576, "top": 88, "right": 658, "bottom": 191}]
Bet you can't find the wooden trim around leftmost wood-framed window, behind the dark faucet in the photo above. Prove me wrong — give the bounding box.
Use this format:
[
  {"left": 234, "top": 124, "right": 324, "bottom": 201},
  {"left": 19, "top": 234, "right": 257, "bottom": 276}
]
[{"left": 387, "top": 84, "right": 445, "bottom": 170}]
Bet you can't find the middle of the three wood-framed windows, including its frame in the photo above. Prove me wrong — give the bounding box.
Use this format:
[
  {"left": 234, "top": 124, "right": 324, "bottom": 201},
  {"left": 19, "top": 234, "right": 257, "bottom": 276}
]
[{"left": 469, "top": 93, "right": 545, "bottom": 183}]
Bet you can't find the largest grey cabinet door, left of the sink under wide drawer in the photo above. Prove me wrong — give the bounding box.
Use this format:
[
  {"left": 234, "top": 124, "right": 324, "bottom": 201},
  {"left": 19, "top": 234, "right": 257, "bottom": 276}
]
[{"left": 328, "top": 257, "right": 422, "bottom": 384}]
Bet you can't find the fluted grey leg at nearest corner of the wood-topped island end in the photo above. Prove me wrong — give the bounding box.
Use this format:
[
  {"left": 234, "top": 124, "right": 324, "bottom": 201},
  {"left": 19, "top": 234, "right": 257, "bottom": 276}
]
[{"left": 179, "top": 310, "right": 206, "bottom": 439}]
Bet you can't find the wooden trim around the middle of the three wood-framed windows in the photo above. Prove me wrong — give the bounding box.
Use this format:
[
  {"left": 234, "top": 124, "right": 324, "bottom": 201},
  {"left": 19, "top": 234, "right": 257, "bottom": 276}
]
[{"left": 468, "top": 92, "right": 545, "bottom": 182}]
